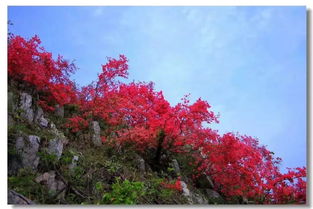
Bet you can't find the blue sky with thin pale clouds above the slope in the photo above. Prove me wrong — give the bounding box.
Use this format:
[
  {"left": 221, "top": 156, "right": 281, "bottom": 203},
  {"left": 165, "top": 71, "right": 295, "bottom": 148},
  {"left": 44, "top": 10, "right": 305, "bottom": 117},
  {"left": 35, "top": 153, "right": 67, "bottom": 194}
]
[{"left": 8, "top": 6, "right": 307, "bottom": 170}]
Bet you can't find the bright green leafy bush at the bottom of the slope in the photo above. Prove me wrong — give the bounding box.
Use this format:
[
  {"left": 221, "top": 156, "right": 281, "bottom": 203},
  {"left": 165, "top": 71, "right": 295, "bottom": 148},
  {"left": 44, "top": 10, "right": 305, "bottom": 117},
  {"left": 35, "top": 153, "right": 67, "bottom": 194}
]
[{"left": 101, "top": 178, "right": 145, "bottom": 205}]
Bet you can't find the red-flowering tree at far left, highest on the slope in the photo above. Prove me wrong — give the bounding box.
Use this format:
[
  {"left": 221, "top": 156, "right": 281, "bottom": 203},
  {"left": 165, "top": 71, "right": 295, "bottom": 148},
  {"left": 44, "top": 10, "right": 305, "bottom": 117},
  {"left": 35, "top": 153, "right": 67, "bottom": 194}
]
[{"left": 8, "top": 35, "right": 77, "bottom": 110}]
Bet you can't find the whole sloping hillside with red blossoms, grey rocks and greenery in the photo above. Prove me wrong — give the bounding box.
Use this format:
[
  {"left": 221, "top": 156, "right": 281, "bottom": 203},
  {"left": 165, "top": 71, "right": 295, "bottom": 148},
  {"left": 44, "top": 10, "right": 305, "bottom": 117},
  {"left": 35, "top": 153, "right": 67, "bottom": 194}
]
[{"left": 8, "top": 35, "right": 306, "bottom": 204}]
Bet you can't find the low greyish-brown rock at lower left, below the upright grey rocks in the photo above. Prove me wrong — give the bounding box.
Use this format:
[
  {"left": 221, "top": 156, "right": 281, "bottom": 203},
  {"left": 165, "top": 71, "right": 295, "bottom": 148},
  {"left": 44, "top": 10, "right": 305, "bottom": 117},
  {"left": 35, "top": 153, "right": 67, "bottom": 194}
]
[{"left": 35, "top": 171, "right": 65, "bottom": 192}]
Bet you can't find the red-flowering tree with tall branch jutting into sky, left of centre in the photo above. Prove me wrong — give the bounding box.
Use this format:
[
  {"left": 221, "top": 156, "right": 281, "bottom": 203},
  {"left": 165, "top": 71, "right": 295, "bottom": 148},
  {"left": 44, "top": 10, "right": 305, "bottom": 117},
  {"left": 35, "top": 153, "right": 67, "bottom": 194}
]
[{"left": 67, "top": 55, "right": 128, "bottom": 132}]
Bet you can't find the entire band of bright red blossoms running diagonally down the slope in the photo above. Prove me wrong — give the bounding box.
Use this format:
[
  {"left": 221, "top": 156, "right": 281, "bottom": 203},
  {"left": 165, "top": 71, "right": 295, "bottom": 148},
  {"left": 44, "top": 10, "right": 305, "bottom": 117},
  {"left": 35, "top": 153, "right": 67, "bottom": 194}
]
[{"left": 8, "top": 36, "right": 306, "bottom": 204}]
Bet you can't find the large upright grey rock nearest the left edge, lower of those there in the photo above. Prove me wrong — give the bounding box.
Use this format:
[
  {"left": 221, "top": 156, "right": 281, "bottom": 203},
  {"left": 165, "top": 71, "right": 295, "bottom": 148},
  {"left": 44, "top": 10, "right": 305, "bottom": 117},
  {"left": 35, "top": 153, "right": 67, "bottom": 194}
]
[{"left": 15, "top": 135, "right": 40, "bottom": 170}]
